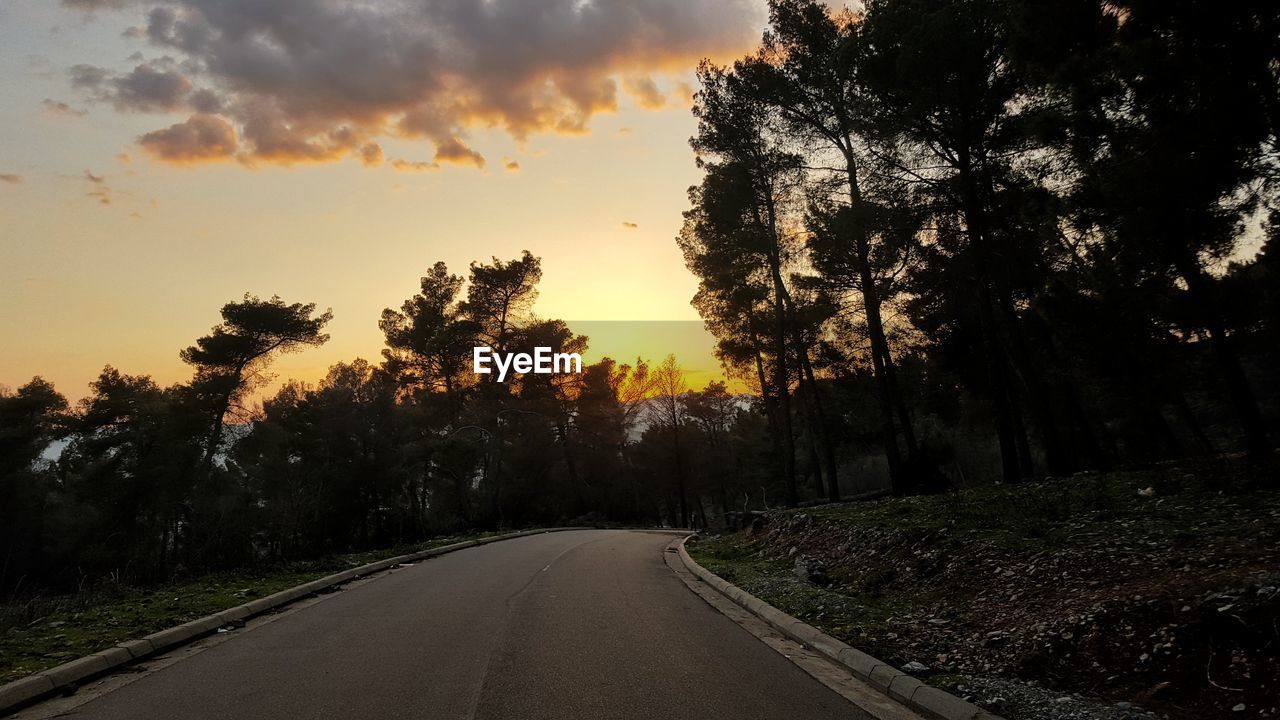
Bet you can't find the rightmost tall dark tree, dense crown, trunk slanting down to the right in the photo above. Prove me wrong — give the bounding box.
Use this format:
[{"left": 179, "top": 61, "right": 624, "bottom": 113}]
[{"left": 1021, "top": 0, "right": 1280, "bottom": 457}]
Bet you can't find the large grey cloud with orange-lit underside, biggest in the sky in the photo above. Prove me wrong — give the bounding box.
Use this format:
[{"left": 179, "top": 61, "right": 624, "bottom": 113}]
[{"left": 64, "top": 0, "right": 763, "bottom": 167}]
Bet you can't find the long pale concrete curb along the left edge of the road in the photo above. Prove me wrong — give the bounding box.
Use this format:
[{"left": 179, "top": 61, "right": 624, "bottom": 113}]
[{"left": 0, "top": 527, "right": 588, "bottom": 715}]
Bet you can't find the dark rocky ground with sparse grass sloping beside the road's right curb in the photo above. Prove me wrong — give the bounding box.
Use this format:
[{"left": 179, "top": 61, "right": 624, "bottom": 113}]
[{"left": 691, "top": 459, "right": 1280, "bottom": 720}]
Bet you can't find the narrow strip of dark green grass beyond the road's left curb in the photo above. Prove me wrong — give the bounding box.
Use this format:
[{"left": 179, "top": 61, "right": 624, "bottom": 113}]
[{"left": 0, "top": 533, "right": 494, "bottom": 683}]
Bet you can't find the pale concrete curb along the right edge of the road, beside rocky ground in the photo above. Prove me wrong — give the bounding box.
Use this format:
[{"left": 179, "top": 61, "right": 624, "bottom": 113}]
[{"left": 677, "top": 538, "right": 1004, "bottom": 720}]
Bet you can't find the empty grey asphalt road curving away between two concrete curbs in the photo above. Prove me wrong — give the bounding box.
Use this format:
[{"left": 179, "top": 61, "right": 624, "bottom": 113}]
[{"left": 35, "top": 530, "right": 869, "bottom": 720}]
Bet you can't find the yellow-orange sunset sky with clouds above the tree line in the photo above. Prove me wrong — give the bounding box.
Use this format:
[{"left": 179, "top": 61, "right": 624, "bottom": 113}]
[{"left": 0, "top": 0, "right": 764, "bottom": 398}]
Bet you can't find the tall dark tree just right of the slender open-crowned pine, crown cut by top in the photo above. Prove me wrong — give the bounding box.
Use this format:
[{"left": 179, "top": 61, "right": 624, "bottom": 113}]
[{"left": 858, "top": 0, "right": 1049, "bottom": 482}]
